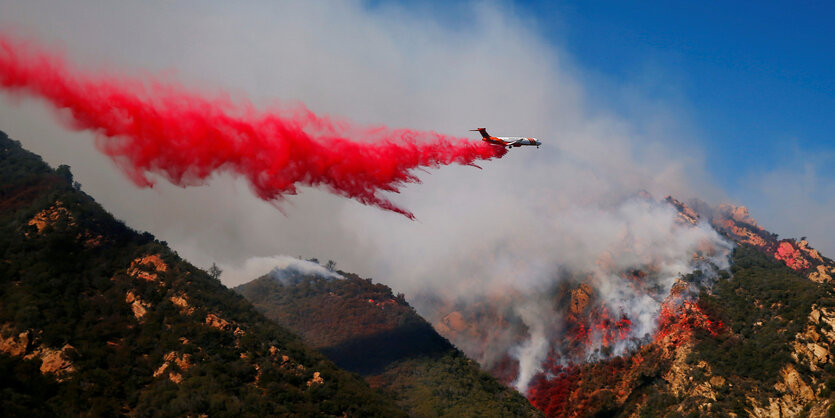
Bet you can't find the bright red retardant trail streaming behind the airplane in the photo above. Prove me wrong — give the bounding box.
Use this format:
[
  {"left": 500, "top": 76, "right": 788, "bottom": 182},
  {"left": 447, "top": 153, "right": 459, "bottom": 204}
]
[{"left": 0, "top": 33, "right": 507, "bottom": 219}]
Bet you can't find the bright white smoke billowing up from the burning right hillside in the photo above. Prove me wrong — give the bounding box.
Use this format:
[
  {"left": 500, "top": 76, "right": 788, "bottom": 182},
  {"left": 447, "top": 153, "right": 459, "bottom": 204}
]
[{"left": 386, "top": 197, "right": 730, "bottom": 393}]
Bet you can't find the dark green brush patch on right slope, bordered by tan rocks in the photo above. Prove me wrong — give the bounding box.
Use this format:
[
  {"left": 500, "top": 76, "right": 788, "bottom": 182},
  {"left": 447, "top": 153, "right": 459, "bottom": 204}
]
[{"left": 691, "top": 246, "right": 835, "bottom": 409}]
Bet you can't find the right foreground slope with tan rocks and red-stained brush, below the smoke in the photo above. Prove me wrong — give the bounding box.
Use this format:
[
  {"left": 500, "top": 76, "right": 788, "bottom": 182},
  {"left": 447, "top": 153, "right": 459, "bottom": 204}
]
[{"left": 528, "top": 198, "right": 835, "bottom": 417}]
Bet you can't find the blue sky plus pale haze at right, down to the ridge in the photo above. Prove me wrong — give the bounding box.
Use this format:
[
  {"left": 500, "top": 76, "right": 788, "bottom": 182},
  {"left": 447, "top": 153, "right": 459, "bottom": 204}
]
[{"left": 519, "top": 1, "right": 835, "bottom": 248}]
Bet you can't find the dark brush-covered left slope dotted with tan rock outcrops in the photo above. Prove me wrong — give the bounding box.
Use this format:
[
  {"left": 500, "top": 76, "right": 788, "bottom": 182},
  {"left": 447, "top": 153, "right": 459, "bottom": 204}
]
[{"left": 0, "top": 133, "right": 403, "bottom": 416}]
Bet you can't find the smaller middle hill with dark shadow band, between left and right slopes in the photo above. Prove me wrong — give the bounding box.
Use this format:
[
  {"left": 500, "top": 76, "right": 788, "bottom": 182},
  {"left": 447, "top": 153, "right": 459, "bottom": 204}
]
[{"left": 235, "top": 272, "right": 537, "bottom": 416}]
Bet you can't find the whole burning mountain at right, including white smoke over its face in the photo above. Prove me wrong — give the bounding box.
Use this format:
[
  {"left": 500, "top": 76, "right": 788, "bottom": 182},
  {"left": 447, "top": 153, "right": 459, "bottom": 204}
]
[{"left": 416, "top": 197, "right": 833, "bottom": 416}]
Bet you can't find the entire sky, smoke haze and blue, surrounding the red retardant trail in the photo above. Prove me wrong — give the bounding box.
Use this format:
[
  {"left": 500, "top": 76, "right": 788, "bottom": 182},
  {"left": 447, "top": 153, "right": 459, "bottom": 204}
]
[{"left": 0, "top": 0, "right": 835, "bottom": 278}]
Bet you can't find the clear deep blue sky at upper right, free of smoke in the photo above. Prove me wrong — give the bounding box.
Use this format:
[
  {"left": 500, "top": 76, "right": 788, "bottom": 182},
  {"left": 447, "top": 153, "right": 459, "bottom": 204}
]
[{"left": 525, "top": 1, "right": 835, "bottom": 184}]
